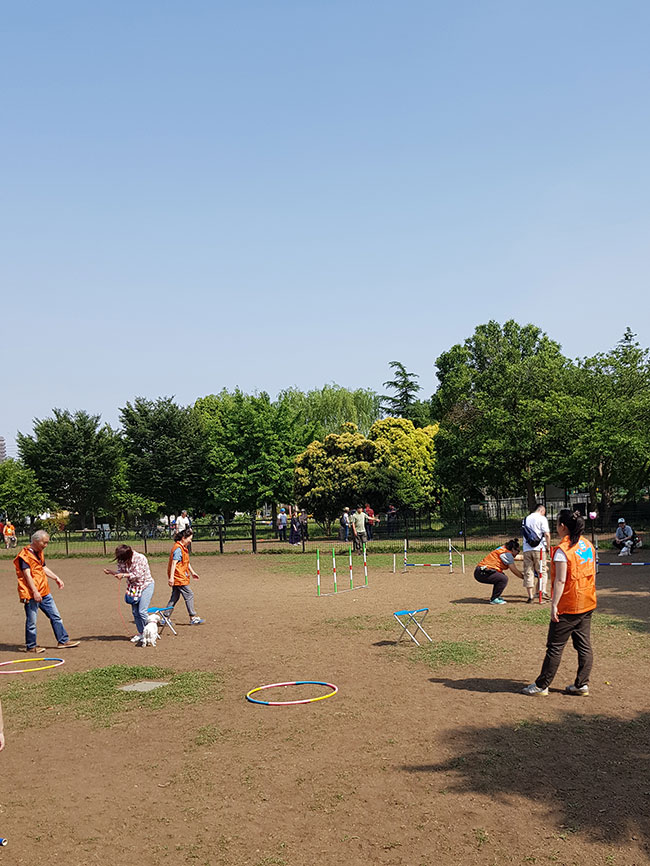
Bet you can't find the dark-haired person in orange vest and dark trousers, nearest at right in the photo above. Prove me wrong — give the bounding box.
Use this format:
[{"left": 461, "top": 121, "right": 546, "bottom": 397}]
[{"left": 523, "top": 508, "right": 596, "bottom": 697}]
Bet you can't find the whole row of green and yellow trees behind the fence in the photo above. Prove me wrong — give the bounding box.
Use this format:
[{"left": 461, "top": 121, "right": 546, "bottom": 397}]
[{"left": 0, "top": 321, "right": 650, "bottom": 525}]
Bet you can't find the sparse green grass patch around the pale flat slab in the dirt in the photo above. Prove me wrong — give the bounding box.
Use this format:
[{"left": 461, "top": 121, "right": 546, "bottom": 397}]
[{"left": 3, "top": 665, "right": 220, "bottom": 728}]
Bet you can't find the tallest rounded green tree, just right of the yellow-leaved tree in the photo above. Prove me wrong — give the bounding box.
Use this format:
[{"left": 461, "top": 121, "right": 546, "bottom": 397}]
[{"left": 432, "top": 320, "right": 570, "bottom": 508}]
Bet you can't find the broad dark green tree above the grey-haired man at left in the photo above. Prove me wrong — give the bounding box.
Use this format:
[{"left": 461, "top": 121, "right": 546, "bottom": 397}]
[{"left": 18, "top": 409, "right": 121, "bottom": 526}]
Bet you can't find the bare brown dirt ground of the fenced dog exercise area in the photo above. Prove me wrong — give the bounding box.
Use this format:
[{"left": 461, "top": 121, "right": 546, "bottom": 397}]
[{"left": 0, "top": 555, "right": 650, "bottom": 866}]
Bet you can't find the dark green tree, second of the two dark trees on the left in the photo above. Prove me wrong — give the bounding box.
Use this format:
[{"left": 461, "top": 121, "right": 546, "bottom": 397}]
[{"left": 120, "top": 397, "right": 206, "bottom": 514}]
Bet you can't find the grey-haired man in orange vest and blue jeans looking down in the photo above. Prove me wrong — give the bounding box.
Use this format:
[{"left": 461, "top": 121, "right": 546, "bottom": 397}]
[{"left": 14, "top": 529, "right": 79, "bottom": 653}]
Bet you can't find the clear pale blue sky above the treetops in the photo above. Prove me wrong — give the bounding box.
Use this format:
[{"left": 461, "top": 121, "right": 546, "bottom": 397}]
[{"left": 0, "top": 0, "right": 650, "bottom": 453}]
